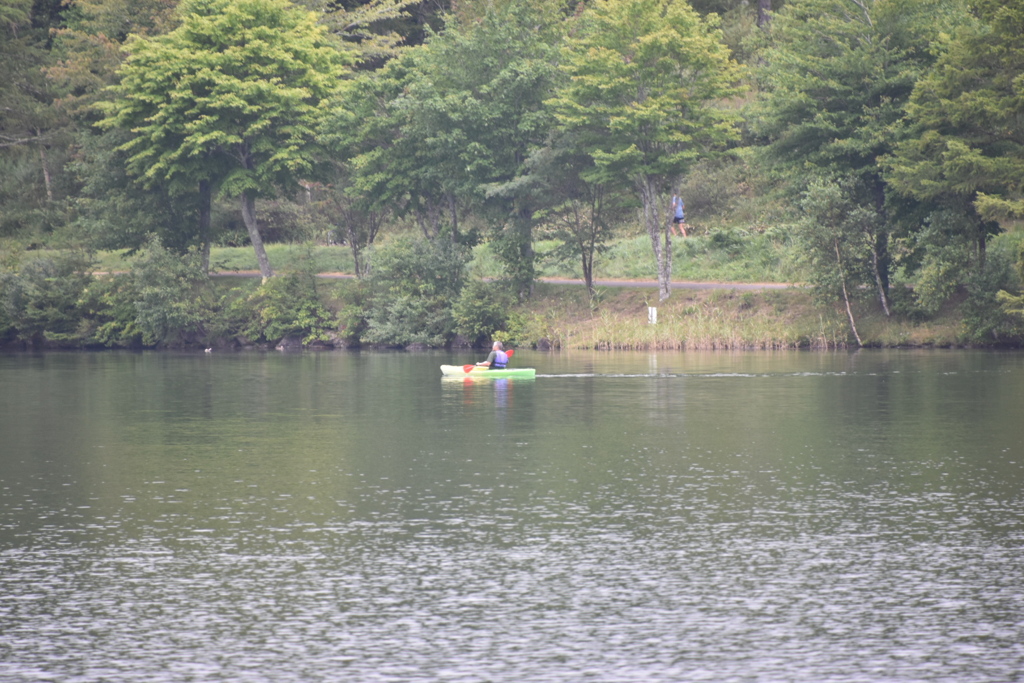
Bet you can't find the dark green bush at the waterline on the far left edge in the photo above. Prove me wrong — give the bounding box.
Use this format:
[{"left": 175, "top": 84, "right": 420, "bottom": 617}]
[{"left": 0, "top": 252, "right": 92, "bottom": 346}]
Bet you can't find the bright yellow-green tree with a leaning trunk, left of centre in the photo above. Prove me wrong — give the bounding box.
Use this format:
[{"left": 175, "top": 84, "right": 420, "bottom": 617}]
[{"left": 101, "top": 0, "right": 351, "bottom": 279}]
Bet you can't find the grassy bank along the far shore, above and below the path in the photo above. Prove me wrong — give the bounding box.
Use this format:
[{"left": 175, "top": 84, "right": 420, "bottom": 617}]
[{"left": 6, "top": 231, "right": 1022, "bottom": 350}]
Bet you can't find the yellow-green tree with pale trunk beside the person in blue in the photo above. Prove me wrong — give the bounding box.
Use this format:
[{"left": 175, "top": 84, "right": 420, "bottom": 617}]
[{"left": 549, "top": 0, "right": 742, "bottom": 300}]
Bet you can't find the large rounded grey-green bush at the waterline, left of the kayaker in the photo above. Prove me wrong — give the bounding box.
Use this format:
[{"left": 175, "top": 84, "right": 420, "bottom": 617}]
[{"left": 361, "top": 237, "right": 469, "bottom": 346}]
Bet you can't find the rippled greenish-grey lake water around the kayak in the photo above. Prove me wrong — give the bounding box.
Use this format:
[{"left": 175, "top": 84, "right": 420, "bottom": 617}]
[{"left": 0, "top": 350, "right": 1024, "bottom": 683}]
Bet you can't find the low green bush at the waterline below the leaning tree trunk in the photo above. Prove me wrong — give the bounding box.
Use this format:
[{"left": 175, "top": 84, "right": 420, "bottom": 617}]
[{"left": 221, "top": 272, "right": 338, "bottom": 344}]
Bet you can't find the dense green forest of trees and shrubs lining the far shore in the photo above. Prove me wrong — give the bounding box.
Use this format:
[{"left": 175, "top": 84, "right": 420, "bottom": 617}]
[{"left": 0, "top": 0, "right": 1024, "bottom": 348}]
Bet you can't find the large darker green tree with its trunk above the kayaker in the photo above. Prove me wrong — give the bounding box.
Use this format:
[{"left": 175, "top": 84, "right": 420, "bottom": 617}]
[{"left": 331, "top": 0, "right": 561, "bottom": 294}]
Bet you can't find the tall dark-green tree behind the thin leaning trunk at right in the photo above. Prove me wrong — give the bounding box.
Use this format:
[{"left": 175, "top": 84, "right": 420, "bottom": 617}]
[{"left": 751, "top": 0, "right": 961, "bottom": 314}]
